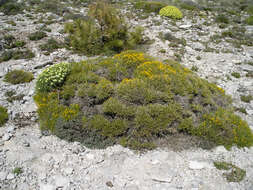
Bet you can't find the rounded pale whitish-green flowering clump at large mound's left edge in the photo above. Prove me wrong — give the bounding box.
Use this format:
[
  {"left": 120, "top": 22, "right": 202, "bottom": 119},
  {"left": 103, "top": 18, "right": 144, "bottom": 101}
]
[{"left": 36, "top": 63, "right": 70, "bottom": 92}]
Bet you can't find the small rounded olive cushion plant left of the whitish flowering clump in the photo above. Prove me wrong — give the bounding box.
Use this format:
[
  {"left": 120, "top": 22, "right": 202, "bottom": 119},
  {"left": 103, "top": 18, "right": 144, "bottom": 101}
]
[{"left": 4, "top": 70, "right": 34, "bottom": 84}]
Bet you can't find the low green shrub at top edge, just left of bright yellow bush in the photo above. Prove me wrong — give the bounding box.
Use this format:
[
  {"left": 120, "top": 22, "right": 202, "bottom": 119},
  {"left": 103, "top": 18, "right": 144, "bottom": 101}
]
[{"left": 134, "top": 1, "right": 166, "bottom": 13}]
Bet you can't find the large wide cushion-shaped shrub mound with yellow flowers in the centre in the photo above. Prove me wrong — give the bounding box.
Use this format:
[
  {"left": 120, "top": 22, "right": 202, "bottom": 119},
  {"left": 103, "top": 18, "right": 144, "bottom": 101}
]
[{"left": 34, "top": 51, "right": 253, "bottom": 150}]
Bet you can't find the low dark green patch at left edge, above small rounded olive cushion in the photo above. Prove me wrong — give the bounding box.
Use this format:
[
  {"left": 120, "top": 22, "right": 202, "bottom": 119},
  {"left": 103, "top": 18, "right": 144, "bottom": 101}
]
[{"left": 0, "top": 49, "right": 35, "bottom": 63}]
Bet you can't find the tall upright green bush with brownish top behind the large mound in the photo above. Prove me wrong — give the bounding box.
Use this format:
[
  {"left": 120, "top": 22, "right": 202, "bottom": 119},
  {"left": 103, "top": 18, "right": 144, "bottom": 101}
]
[{"left": 65, "top": 1, "right": 143, "bottom": 55}]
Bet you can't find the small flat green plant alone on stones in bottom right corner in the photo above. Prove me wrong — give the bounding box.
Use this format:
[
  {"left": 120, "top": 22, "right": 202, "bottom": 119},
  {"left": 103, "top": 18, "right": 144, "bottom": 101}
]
[{"left": 214, "top": 162, "right": 246, "bottom": 182}]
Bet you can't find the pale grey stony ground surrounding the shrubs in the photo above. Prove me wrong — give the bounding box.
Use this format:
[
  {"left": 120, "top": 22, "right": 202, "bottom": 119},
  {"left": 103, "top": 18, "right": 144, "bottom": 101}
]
[{"left": 0, "top": 0, "right": 253, "bottom": 190}]
